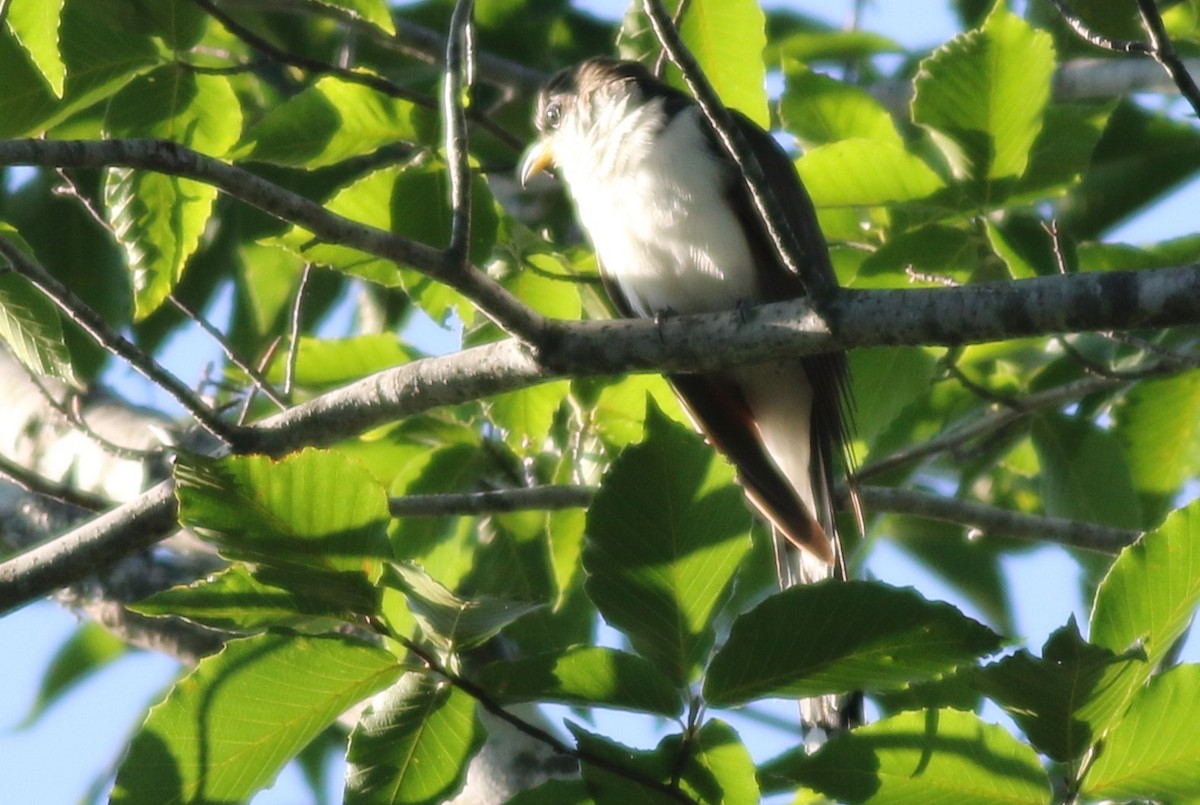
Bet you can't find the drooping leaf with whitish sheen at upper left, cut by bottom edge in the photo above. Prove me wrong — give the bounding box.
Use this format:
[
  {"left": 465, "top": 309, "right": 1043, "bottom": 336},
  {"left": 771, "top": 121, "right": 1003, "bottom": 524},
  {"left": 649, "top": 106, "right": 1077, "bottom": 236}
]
[{"left": 346, "top": 673, "right": 486, "bottom": 805}]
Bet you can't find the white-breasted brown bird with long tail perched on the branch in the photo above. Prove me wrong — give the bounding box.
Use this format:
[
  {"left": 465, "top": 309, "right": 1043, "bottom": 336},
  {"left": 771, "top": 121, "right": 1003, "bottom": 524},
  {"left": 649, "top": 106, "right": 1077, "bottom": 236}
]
[{"left": 520, "top": 58, "right": 851, "bottom": 611}]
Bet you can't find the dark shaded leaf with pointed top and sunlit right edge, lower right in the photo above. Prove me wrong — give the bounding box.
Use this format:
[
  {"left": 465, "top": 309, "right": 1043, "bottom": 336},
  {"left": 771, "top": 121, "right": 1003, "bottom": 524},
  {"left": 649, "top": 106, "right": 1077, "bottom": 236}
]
[{"left": 974, "top": 618, "right": 1146, "bottom": 763}]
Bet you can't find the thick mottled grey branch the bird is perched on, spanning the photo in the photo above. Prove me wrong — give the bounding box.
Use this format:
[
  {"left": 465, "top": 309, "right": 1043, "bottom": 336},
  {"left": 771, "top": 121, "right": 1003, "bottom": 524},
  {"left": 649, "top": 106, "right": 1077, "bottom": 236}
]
[{"left": 0, "top": 265, "right": 1200, "bottom": 612}]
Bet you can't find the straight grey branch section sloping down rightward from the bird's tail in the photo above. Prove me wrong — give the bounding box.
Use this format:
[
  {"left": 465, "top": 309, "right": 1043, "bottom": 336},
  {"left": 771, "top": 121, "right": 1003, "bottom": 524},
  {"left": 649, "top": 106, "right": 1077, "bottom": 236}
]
[{"left": 857, "top": 486, "right": 1139, "bottom": 553}]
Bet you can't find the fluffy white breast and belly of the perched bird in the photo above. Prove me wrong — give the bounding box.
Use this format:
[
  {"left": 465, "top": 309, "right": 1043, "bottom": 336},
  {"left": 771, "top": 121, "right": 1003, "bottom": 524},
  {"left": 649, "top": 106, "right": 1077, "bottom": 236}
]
[{"left": 557, "top": 102, "right": 761, "bottom": 316}]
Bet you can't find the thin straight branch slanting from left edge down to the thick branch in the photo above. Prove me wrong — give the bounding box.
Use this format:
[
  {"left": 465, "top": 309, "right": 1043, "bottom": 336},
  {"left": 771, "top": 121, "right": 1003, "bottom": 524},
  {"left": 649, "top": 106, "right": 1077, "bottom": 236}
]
[{"left": 0, "top": 238, "right": 236, "bottom": 444}]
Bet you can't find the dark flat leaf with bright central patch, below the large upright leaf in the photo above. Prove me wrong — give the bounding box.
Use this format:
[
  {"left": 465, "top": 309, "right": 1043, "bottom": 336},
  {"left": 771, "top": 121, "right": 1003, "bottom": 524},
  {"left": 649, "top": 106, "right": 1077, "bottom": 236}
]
[{"left": 473, "top": 645, "right": 683, "bottom": 719}]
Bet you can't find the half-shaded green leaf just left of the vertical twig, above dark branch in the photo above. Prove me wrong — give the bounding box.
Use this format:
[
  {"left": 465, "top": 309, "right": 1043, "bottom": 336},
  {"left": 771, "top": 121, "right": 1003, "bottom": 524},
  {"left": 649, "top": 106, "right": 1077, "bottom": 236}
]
[{"left": 234, "top": 76, "right": 437, "bottom": 169}]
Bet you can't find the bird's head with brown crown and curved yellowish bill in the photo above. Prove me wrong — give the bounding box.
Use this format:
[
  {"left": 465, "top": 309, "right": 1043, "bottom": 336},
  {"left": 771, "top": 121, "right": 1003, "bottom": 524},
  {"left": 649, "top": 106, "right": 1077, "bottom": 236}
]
[{"left": 521, "top": 58, "right": 661, "bottom": 185}]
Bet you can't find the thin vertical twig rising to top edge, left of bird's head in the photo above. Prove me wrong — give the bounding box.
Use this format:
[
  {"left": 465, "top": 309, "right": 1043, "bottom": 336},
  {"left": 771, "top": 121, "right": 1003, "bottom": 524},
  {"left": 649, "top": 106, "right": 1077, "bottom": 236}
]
[{"left": 442, "top": 0, "right": 475, "bottom": 265}]
